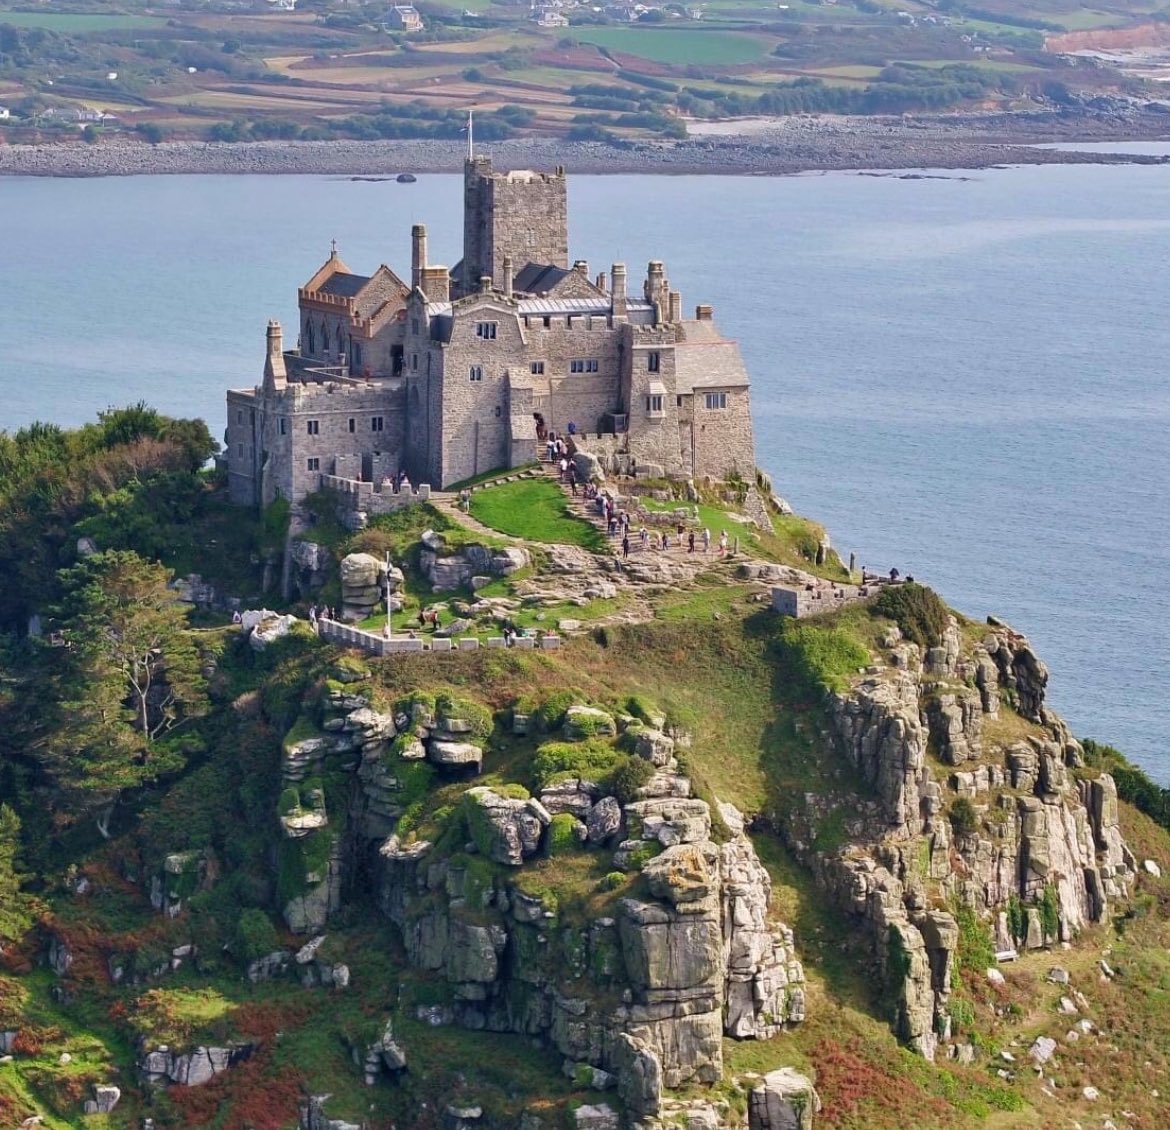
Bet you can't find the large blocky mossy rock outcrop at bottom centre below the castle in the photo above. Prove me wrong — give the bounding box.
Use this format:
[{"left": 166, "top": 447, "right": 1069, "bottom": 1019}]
[{"left": 380, "top": 743, "right": 805, "bottom": 1128}]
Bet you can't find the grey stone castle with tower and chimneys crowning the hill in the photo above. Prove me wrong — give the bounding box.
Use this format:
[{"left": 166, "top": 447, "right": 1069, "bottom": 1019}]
[{"left": 226, "top": 156, "right": 756, "bottom": 505}]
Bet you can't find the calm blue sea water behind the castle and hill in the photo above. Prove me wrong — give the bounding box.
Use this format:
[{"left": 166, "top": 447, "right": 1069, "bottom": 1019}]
[{"left": 0, "top": 156, "right": 1170, "bottom": 784}]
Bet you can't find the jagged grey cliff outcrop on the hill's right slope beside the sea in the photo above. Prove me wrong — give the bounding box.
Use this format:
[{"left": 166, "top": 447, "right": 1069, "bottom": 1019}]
[{"left": 792, "top": 619, "right": 1135, "bottom": 1057}]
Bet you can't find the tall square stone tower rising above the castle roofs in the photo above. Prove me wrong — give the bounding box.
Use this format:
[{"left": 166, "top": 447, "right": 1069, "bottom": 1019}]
[{"left": 459, "top": 157, "right": 569, "bottom": 294}]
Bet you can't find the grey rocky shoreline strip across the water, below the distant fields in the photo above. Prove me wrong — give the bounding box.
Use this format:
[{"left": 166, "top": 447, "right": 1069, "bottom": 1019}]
[{"left": 0, "top": 111, "right": 1170, "bottom": 177}]
